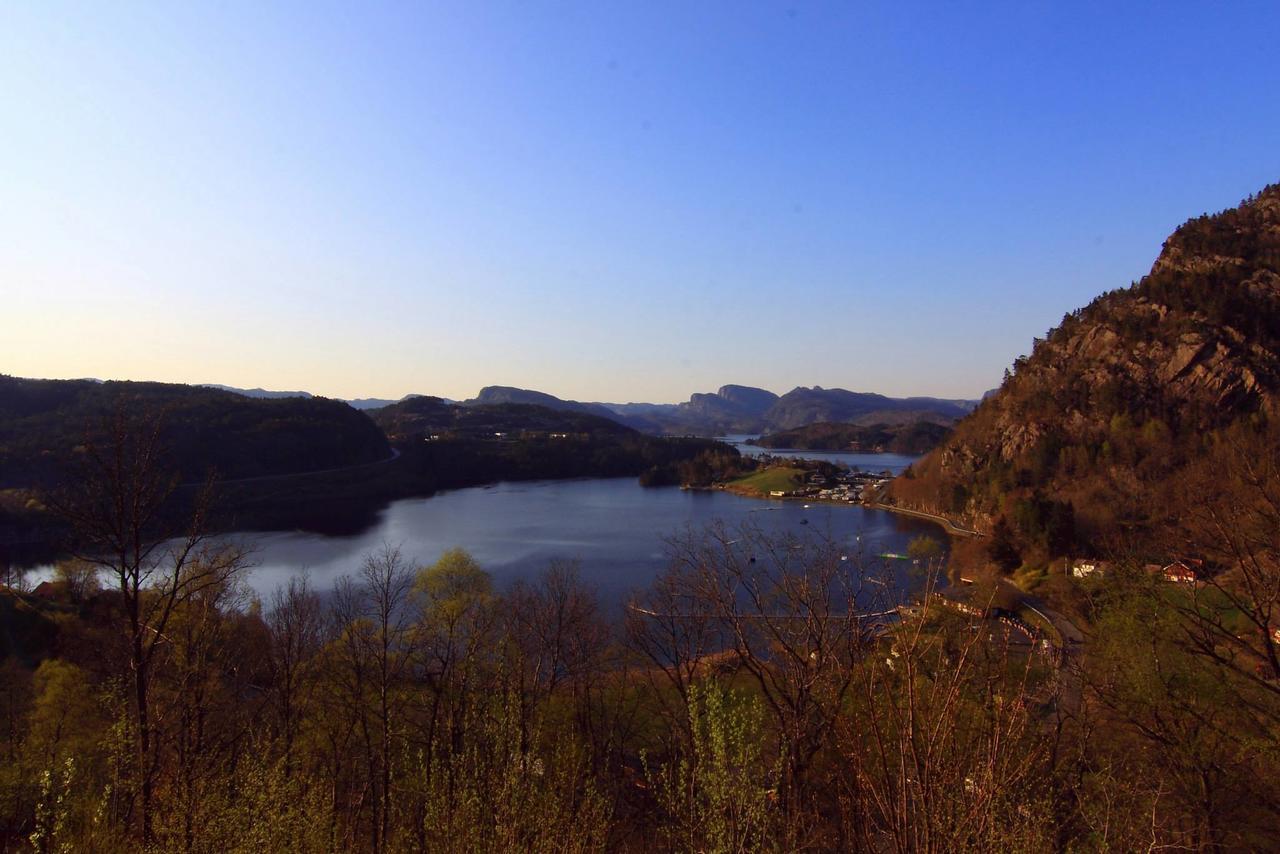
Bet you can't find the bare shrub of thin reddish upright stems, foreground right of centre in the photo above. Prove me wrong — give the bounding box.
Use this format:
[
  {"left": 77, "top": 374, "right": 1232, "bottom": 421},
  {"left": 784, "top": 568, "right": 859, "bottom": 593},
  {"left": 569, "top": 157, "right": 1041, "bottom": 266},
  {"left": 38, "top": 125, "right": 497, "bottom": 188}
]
[{"left": 840, "top": 583, "right": 1050, "bottom": 853}]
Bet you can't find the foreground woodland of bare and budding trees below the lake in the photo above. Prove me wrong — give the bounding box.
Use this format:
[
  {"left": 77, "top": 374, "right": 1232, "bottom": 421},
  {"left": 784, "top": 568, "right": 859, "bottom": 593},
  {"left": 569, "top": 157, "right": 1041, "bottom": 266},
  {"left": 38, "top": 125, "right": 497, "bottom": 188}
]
[{"left": 0, "top": 409, "right": 1280, "bottom": 853}]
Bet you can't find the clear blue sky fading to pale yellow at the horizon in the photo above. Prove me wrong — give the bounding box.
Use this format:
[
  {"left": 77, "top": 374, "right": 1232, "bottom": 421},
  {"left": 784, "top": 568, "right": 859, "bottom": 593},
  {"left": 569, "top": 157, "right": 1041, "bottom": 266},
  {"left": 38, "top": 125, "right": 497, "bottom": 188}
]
[{"left": 0, "top": 1, "right": 1280, "bottom": 401}]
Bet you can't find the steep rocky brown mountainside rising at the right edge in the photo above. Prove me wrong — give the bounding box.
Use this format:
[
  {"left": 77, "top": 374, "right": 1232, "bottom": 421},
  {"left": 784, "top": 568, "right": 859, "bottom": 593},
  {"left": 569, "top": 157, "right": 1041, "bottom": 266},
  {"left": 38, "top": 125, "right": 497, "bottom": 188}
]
[{"left": 892, "top": 186, "right": 1280, "bottom": 553}]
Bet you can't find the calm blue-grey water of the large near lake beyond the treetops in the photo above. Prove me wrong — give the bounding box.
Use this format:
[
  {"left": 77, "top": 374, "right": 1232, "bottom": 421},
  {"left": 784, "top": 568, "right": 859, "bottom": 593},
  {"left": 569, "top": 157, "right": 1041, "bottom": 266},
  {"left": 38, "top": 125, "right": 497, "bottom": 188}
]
[{"left": 237, "top": 478, "right": 946, "bottom": 604}]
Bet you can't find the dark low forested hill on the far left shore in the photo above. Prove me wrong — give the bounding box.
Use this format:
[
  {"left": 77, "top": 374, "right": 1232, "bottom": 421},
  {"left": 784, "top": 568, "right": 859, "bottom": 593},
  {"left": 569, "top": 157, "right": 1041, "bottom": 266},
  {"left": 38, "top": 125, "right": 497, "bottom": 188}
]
[{"left": 0, "top": 375, "right": 390, "bottom": 488}]
